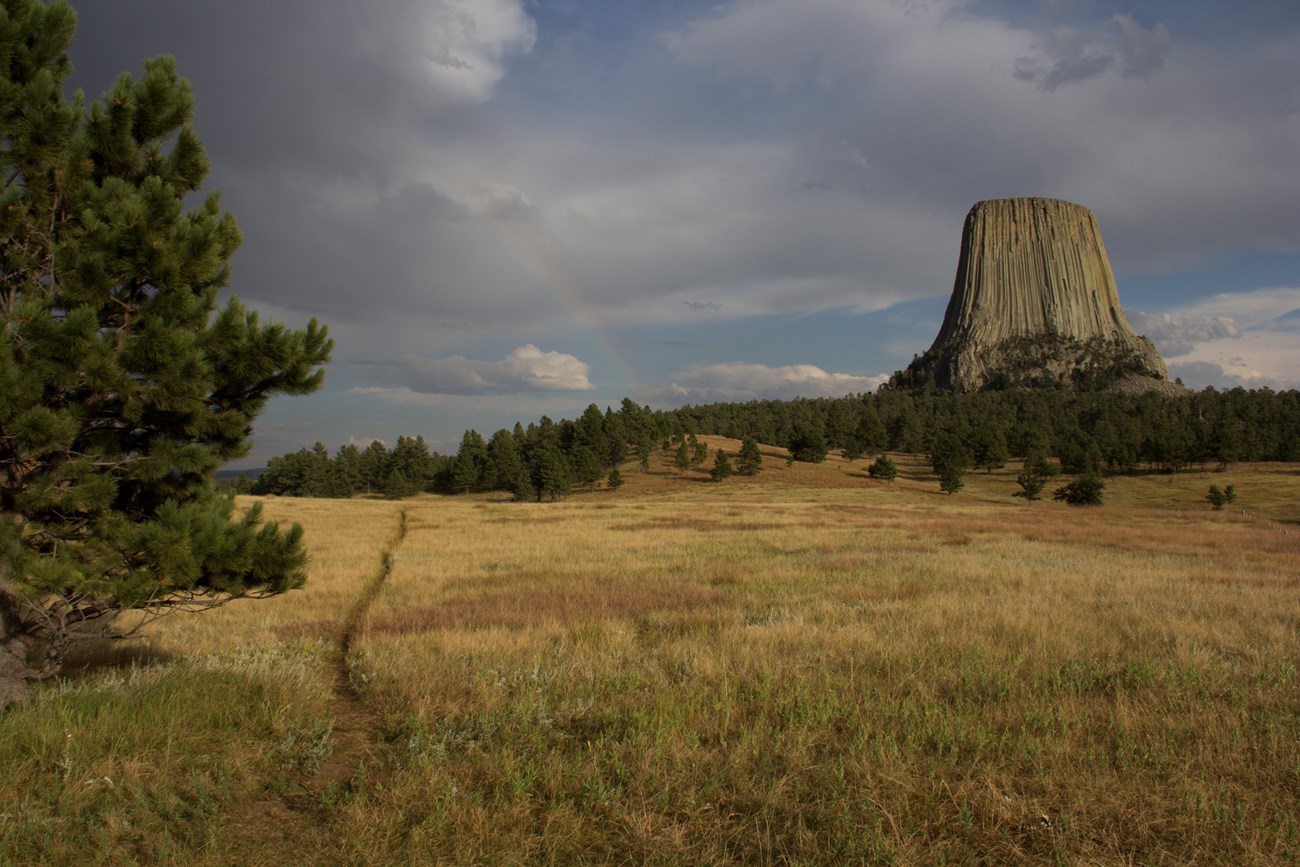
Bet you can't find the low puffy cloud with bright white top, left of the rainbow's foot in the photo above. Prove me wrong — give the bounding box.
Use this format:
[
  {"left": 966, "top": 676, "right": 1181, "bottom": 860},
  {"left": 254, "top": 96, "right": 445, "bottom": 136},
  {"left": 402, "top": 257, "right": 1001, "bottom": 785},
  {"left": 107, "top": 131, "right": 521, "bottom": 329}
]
[{"left": 355, "top": 344, "right": 595, "bottom": 400}]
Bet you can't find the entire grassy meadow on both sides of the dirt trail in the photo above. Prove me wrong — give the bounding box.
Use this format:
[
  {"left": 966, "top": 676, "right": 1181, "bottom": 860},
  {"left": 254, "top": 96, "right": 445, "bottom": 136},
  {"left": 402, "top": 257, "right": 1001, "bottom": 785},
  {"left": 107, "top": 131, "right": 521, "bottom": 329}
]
[{"left": 0, "top": 439, "right": 1300, "bottom": 864}]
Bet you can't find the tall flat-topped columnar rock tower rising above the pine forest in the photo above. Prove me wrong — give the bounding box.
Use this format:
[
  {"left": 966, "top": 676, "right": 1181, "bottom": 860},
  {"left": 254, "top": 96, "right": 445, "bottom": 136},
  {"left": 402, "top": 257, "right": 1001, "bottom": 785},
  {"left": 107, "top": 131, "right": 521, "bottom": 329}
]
[{"left": 891, "top": 199, "right": 1173, "bottom": 391}]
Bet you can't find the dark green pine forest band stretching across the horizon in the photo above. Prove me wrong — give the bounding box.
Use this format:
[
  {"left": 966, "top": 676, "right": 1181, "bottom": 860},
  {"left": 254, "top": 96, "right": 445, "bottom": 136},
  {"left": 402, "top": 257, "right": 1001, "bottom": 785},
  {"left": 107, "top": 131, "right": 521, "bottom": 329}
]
[{"left": 238, "top": 387, "right": 1300, "bottom": 500}]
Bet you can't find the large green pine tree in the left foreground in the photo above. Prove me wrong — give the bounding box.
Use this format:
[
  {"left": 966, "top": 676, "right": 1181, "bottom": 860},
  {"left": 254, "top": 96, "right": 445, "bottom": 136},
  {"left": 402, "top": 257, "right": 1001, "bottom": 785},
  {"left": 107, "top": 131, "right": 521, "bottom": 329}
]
[{"left": 0, "top": 0, "right": 332, "bottom": 705}]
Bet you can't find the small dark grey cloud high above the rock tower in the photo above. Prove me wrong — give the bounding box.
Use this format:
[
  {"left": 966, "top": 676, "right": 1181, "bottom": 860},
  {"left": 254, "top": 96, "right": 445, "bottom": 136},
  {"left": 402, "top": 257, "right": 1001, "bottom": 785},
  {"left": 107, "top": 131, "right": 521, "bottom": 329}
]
[{"left": 1015, "top": 13, "right": 1173, "bottom": 91}]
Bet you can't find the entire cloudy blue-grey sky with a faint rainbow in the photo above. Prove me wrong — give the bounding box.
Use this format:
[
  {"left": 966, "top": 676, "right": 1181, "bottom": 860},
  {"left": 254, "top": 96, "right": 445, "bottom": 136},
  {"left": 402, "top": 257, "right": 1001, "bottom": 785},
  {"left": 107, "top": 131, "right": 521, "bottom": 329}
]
[{"left": 72, "top": 0, "right": 1300, "bottom": 467}]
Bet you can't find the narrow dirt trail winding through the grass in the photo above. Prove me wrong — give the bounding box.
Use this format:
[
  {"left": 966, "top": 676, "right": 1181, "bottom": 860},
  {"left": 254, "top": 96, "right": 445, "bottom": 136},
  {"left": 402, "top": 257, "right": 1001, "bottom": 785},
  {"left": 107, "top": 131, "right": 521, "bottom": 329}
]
[{"left": 212, "top": 510, "right": 407, "bottom": 863}]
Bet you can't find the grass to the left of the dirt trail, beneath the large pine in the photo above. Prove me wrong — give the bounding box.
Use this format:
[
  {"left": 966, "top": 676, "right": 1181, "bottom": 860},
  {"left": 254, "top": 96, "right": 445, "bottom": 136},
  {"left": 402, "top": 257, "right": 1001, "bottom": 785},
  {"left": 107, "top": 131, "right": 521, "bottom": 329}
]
[{"left": 0, "top": 499, "right": 398, "bottom": 864}]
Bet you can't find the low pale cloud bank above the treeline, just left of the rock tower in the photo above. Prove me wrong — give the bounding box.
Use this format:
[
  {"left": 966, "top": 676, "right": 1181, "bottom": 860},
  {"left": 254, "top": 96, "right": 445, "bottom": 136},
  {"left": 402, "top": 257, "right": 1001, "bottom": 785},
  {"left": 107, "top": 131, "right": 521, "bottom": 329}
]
[{"left": 657, "top": 361, "right": 889, "bottom": 406}]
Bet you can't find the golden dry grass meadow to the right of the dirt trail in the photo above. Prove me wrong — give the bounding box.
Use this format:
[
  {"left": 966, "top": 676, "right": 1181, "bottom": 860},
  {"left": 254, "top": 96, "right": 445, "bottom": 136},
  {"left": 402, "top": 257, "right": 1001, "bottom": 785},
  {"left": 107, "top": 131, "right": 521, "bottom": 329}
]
[{"left": 317, "top": 452, "right": 1300, "bottom": 863}]
